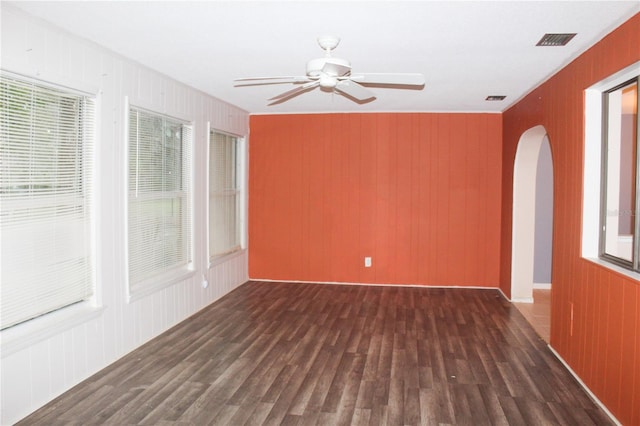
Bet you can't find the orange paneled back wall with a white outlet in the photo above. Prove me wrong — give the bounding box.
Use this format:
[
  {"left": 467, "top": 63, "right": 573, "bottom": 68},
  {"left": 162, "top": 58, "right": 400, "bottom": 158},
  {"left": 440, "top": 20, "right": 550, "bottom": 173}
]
[{"left": 249, "top": 113, "right": 502, "bottom": 287}]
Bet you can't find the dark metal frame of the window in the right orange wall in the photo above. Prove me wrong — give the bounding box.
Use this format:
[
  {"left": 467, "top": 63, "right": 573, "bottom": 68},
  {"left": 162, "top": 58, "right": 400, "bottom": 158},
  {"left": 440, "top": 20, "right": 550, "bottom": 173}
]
[{"left": 596, "top": 73, "right": 640, "bottom": 272}]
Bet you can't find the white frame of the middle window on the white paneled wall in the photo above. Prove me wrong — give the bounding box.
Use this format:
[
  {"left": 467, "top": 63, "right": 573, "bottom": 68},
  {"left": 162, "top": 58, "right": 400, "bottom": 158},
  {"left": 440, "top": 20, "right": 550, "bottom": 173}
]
[{"left": 123, "top": 97, "right": 196, "bottom": 303}]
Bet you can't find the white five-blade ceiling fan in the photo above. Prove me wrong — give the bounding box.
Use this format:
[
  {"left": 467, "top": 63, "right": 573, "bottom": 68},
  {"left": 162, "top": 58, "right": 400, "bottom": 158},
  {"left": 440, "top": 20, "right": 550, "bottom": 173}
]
[{"left": 234, "top": 36, "right": 425, "bottom": 105}]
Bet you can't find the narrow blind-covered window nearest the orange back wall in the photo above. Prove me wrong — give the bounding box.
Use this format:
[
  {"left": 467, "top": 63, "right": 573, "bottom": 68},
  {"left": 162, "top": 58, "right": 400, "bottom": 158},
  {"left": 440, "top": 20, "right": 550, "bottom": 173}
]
[{"left": 209, "top": 131, "right": 242, "bottom": 261}]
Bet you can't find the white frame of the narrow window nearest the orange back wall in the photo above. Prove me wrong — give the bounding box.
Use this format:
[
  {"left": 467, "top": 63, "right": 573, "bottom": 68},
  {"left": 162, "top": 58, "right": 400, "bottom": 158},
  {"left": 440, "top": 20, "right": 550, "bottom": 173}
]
[{"left": 207, "top": 123, "right": 246, "bottom": 268}]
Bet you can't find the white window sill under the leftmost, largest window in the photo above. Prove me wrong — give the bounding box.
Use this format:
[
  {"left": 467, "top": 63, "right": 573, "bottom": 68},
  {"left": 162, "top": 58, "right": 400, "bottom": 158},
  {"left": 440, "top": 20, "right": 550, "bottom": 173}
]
[{"left": 0, "top": 302, "right": 104, "bottom": 358}]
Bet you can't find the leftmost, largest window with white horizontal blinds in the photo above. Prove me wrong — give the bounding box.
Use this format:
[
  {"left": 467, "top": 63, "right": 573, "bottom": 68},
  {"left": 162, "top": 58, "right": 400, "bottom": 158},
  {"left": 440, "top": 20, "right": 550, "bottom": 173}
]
[{"left": 0, "top": 74, "right": 94, "bottom": 329}]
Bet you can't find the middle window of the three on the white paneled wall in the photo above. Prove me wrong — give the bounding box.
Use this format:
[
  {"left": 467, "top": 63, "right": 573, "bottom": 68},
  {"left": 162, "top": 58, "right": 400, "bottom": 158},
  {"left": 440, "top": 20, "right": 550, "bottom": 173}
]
[{"left": 128, "top": 108, "right": 192, "bottom": 296}]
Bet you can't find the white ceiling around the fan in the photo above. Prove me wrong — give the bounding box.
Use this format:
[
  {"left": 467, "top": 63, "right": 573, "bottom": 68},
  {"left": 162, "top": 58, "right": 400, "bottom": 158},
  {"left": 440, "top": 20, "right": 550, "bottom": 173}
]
[{"left": 3, "top": 0, "right": 640, "bottom": 113}]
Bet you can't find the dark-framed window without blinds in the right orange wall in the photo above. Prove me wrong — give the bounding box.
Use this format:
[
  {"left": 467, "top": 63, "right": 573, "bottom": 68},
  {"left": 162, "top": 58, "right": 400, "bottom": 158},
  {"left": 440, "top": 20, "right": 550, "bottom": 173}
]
[{"left": 600, "top": 77, "right": 640, "bottom": 271}]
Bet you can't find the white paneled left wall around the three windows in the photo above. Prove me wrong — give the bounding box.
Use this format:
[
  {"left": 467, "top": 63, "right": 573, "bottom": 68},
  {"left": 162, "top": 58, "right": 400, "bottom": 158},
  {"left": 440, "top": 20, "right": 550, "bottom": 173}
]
[{"left": 0, "top": 4, "right": 248, "bottom": 425}]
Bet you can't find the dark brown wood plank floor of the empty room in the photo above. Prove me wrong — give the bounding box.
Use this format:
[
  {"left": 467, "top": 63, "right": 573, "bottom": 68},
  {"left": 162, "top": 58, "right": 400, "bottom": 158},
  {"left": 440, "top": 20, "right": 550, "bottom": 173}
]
[{"left": 19, "top": 282, "right": 612, "bottom": 426}]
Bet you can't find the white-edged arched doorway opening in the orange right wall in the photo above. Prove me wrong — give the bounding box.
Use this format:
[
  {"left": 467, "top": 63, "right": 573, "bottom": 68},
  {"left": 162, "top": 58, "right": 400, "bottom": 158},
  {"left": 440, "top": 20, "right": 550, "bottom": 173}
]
[{"left": 511, "top": 126, "right": 553, "bottom": 303}]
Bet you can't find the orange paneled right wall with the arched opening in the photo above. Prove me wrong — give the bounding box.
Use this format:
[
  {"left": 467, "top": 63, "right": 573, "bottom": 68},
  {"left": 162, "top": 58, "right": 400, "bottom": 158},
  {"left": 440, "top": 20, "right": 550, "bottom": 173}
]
[{"left": 500, "top": 11, "right": 640, "bottom": 425}]
